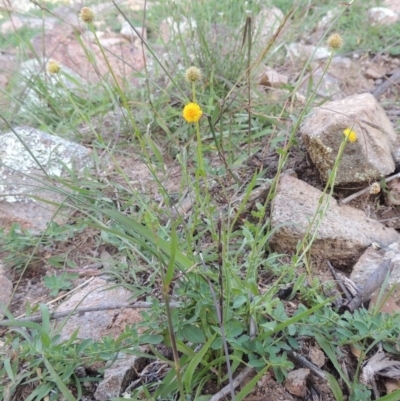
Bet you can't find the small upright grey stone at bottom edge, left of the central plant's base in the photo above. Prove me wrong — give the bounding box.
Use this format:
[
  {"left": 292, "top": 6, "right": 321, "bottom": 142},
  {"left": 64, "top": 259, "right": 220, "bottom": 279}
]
[{"left": 94, "top": 354, "right": 145, "bottom": 401}]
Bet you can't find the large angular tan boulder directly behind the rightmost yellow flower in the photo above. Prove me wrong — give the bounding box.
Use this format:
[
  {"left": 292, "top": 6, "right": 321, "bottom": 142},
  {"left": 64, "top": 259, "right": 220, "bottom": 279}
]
[{"left": 301, "top": 93, "right": 400, "bottom": 184}]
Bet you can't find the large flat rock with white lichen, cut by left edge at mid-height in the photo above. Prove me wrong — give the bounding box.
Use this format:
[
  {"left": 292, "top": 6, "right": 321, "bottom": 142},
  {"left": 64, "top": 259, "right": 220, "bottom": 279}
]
[{"left": 0, "top": 128, "right": 90, "bottom": 233}]
